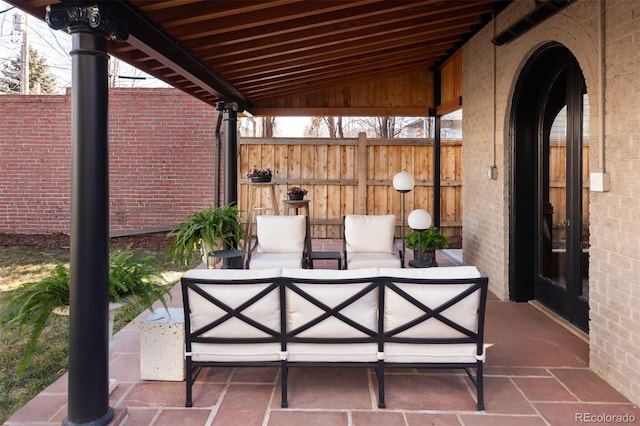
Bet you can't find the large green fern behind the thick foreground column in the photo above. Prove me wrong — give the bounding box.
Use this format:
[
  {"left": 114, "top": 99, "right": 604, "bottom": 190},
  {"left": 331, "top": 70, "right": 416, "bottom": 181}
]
[{"left": 0, "top": 246, "right": 171, "bottom": 376}]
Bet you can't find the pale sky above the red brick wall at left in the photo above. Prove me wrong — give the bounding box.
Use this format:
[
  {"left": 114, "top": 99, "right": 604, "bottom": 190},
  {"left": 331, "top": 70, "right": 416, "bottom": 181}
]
[{"left": 0, "top": 1, "right": 168, "bottom": 94}]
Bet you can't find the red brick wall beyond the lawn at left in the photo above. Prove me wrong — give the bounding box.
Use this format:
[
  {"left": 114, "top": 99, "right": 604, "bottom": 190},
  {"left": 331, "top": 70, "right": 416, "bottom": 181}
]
[{"left": 0, "top": 89, "right": 224, "bottom": 234}]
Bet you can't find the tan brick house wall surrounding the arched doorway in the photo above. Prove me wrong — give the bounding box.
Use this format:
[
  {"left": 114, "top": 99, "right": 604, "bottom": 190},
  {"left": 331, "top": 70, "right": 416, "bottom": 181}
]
[{"left": 462, "top": 0, "right": 640, "bottom": 404}]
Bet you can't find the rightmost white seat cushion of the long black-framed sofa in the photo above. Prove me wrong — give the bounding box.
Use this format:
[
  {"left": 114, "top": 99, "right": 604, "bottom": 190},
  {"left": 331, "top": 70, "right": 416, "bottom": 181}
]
[{"left": 384, "top": 343, "right": 478, "bottom": 363}]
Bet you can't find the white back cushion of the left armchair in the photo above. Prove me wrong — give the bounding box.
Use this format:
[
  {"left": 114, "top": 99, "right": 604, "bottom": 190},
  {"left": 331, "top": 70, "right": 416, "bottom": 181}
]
[{"left": 251, "top": 215, "right": 307, "bottom": 253}]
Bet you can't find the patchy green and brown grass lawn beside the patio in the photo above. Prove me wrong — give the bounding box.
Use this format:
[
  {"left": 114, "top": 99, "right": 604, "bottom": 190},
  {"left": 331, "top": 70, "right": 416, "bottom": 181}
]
[{"left": 0, "top": 243, "right": 181, "bottom": 424}]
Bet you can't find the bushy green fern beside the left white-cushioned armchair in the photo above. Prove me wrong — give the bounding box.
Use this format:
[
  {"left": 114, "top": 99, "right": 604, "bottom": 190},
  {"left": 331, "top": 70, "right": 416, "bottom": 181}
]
[{"left": 169, "top": 204, "right": 245, "bottom": 266}]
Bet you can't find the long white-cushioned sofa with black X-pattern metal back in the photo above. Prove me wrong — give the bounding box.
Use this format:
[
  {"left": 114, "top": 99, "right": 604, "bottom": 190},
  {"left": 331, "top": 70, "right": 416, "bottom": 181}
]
[{"left": 182, "top": 266, "right": 488, "bottom": 410}]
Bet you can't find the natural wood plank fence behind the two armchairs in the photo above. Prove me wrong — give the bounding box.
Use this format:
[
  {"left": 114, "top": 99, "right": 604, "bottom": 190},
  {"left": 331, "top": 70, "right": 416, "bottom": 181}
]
[{"left": 238, "top": 134, "right": 462, "bottom": 238}]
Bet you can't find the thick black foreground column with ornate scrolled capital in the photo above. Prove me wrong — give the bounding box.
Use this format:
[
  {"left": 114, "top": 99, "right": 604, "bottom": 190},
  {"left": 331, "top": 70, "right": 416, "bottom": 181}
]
[{"left": 46, "top": 5, "right": 126, "bottom": 425}]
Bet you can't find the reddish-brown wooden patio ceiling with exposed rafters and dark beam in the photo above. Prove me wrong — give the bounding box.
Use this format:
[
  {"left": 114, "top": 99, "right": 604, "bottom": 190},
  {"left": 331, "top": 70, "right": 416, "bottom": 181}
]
[{"left": 11, "top": 0, "right": 509, "bottom": 112}]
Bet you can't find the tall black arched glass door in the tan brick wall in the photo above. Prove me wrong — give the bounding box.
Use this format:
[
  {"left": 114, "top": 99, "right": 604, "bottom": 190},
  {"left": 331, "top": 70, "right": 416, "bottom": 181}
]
[{"left": 510, "top": 44, "right": 589, "bottom": 331}]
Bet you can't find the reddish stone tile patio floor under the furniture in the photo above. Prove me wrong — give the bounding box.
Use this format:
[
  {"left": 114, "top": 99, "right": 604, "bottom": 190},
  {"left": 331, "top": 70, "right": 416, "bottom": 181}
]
[{"left": 5, "top": 240, "right": 640, "bottom": 426}]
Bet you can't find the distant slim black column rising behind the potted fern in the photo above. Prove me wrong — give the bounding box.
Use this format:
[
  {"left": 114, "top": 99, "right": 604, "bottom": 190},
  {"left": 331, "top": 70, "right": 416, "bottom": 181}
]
[{"left": 216, "top": 102, "right": 239, "bottom": 205}]
